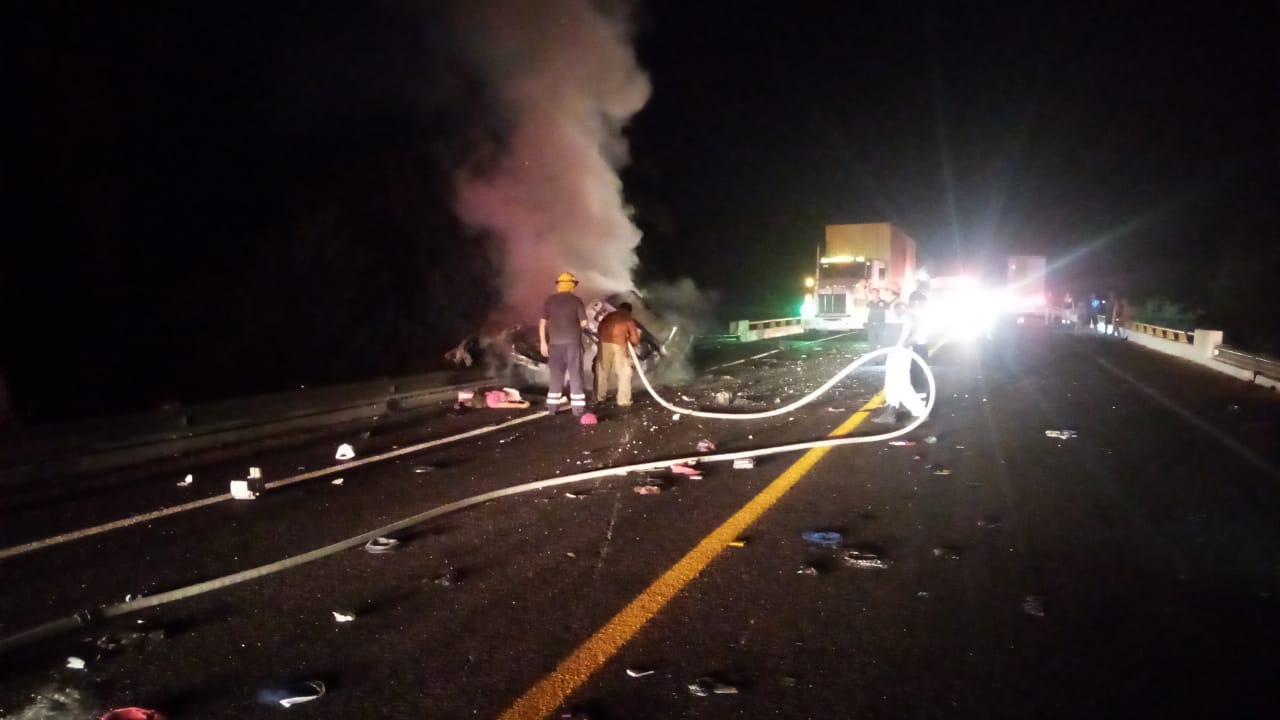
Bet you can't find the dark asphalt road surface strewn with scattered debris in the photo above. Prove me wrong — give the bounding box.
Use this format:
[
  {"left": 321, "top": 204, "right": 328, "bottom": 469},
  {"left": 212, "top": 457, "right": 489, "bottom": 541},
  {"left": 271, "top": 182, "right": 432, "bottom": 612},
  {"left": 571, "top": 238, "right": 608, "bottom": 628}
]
[{"left": 0, "top": 328, "right": 1280, "bottom": 720}]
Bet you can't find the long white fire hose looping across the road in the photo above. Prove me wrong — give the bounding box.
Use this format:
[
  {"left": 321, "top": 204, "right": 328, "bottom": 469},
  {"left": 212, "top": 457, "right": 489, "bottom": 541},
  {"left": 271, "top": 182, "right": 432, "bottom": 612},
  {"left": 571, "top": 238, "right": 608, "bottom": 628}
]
[{"left": 0, "top": 347, "right": 937, "bottom": 653}]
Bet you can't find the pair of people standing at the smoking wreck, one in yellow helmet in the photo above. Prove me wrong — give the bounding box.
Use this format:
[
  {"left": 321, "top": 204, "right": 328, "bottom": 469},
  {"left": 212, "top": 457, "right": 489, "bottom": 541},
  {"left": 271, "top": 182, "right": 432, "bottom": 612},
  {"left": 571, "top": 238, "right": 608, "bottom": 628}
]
[{"left": 538, "top": 273, "right": 640, "bottom": 418}]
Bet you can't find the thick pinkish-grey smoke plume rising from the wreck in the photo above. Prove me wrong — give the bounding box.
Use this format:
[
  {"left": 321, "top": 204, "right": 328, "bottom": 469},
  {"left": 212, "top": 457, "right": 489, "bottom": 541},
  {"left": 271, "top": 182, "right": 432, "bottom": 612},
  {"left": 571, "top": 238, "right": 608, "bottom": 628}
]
[{"left": 454, "top": 0, "right": 650, "bottom": 319}]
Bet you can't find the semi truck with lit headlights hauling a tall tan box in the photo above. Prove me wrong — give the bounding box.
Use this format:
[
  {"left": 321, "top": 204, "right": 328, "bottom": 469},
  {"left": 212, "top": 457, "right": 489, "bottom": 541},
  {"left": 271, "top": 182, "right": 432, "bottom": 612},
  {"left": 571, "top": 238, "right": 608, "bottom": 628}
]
[{"left": 805, "top": 223, "right": 915, "bottom": 331}]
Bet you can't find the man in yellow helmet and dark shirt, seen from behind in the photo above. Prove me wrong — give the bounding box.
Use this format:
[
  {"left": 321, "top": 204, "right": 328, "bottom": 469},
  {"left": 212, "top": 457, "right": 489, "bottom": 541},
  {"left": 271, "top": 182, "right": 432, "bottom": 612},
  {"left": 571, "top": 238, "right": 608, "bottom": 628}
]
[{"left": 538, "top": 273, "right": 586, "bottom": 416}]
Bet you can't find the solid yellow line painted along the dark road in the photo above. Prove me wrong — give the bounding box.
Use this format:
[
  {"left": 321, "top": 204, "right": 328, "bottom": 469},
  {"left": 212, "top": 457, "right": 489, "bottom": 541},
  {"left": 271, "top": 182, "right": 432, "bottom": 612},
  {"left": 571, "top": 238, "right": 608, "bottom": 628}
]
[{"left": 500, "top": 393, "right": 883, "bottom": 720}]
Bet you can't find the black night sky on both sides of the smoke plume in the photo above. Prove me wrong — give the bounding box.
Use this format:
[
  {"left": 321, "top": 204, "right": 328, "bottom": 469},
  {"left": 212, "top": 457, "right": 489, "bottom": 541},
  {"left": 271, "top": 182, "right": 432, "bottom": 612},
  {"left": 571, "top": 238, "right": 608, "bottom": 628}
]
[{"left": 0, "top": 0, "right": 1280, "bottom": 424}]
